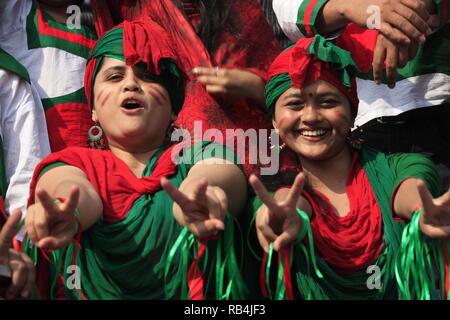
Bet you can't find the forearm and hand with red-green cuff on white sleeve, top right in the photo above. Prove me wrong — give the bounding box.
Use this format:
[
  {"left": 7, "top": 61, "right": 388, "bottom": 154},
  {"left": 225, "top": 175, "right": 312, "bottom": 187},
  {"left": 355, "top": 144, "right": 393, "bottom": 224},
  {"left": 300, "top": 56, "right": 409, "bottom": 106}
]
[{"left": 273, "top": 0, "right": 435, "bottom": 44}]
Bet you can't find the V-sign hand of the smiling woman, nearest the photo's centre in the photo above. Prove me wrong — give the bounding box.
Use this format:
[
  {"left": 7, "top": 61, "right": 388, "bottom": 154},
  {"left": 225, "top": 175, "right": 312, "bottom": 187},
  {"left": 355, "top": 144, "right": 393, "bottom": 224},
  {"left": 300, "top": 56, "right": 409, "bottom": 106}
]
[{"left": 249, "top": 173, "right": 305, "bottom": 252}]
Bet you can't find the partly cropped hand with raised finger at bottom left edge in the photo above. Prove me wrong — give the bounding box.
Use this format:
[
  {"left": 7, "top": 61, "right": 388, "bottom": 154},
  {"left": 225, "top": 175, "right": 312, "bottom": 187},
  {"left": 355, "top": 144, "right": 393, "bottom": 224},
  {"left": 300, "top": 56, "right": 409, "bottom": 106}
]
[{"left": 0, "top": 210, "right": 36, "bottom": 299}]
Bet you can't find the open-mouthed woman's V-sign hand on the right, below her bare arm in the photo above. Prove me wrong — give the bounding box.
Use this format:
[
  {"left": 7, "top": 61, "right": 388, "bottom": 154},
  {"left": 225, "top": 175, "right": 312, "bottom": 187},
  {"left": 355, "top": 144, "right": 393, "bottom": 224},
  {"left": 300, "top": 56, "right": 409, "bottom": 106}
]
[{"left": 161, "top": 178, "right": 228, "bottom": 238}]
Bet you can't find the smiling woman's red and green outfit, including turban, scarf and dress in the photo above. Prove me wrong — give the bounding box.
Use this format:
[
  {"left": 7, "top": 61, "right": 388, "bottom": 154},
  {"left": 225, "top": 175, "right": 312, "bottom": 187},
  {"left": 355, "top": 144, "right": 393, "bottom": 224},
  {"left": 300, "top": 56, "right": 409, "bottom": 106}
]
[{"left": 253, "top": 36, "right": 449, "bottom": 299}]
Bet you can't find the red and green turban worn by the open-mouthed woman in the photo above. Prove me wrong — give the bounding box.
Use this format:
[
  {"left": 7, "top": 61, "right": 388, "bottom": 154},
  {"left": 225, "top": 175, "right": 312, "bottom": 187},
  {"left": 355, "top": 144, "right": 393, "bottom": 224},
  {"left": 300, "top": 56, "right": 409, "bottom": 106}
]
[{"left": 84, "top": 18, "right": 185, "bottom": 113}]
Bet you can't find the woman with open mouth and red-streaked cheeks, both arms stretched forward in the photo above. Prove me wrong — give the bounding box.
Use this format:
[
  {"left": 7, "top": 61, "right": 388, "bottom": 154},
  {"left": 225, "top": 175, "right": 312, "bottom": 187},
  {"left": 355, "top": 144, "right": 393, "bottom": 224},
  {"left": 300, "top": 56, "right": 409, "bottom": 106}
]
[{"left": 18, "top": 19, "right": 250, "bottom": 299}]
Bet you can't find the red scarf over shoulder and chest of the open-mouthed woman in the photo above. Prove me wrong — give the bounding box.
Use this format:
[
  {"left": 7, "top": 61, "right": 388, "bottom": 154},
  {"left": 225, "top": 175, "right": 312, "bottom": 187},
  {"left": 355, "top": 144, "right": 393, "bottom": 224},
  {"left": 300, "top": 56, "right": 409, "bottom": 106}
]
[{"left": 28, "top": 145, "right": 176, "bottom": 222}]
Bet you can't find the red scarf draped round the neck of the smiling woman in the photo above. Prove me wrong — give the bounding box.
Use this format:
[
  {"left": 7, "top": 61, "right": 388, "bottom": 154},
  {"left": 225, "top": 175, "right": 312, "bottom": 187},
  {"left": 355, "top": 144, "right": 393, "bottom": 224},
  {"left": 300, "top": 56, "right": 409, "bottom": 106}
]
[{"left": 304, "top": 152, "right": 383, "bottom": 274}]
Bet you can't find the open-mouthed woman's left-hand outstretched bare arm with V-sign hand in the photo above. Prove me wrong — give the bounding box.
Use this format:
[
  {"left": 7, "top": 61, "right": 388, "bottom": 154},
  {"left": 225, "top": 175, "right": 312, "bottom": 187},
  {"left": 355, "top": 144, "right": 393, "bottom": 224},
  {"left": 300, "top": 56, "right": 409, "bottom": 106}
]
[{"left": 25, "top": 166, "right": 103, "bottom": 249}]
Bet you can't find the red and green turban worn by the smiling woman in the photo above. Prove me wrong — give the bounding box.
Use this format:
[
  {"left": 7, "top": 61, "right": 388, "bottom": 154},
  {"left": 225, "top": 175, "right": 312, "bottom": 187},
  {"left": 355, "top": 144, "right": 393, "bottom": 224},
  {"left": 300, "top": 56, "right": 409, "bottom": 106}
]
[{"left": 264, "top": 35, "right": 359, "bottom": 115}]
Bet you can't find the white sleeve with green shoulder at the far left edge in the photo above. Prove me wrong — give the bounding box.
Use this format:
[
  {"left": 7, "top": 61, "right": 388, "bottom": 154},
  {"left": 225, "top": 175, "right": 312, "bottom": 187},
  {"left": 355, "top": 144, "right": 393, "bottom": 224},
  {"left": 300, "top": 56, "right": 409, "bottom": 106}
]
[{"left": 0, "top": 49, "right": 50, "bottom": 222}]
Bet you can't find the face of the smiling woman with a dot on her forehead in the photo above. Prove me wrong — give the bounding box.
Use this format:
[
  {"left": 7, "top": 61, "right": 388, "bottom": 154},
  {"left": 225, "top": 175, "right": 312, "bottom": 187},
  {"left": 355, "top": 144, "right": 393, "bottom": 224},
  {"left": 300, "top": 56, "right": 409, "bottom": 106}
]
[{"left": 272, "top": 80, "right": 353, "bottom": 160}]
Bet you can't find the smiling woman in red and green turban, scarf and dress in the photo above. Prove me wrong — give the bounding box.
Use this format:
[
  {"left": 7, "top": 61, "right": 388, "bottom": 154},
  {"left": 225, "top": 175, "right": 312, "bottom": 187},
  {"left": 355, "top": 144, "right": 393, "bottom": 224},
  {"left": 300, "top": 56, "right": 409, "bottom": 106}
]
[{"left": 250, "top": 36, "right": 450, "bottom": 299}]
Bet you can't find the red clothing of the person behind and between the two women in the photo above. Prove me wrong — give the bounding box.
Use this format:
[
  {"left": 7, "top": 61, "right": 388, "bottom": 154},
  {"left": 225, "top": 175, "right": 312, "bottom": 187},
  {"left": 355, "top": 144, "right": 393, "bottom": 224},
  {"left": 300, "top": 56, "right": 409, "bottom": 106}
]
[{"left": 88, "top": 0, "right": 293, "bottom": 175}]
